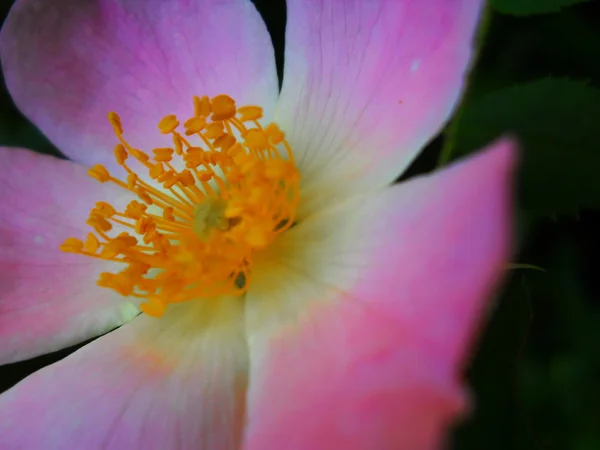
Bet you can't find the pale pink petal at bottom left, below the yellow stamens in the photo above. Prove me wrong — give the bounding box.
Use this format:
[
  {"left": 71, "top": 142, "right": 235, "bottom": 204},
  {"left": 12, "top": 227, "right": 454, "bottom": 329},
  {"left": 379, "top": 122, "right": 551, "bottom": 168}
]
[{"left": 0, "top": 298, "right": 248, "bottom": 450}]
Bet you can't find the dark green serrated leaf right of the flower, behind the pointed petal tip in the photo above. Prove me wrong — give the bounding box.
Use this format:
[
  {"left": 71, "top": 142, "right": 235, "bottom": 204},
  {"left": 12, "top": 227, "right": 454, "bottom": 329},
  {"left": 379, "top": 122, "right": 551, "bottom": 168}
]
[{"left": 440, "top": 78, "right": 600, "bottom": 214}]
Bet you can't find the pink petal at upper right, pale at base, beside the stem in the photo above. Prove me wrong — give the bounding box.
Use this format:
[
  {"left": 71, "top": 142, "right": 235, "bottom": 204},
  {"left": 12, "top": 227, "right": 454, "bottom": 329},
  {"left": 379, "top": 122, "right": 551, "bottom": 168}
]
[{"left": 275, "top": 0, "right": 483, "bottom": 215}]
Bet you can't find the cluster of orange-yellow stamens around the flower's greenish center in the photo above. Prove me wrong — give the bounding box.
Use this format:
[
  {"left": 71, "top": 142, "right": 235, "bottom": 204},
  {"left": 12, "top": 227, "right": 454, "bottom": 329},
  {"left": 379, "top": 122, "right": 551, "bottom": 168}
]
[{"left": 60, "top": 95, "right": 300, "bottom": 317}]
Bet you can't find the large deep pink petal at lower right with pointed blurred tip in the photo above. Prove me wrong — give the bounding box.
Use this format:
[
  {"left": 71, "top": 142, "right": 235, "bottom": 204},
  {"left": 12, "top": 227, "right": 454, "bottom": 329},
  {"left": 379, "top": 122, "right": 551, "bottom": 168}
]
[{"left": 244, "top": 140, "right": 514, "bottom": 450}]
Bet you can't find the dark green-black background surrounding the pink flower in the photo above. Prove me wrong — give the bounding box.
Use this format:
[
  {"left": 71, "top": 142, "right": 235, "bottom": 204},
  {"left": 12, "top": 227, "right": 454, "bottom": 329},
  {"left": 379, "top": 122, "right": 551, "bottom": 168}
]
[{"left": 0, "top": 0, "right": 600, "bottom": 450}]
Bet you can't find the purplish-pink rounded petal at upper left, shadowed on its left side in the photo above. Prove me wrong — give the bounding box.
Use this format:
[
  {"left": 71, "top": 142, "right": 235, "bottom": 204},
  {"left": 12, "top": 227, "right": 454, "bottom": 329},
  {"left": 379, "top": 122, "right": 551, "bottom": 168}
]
[{"left": 0, "top": 0, "right": 278, "bottom": 166}]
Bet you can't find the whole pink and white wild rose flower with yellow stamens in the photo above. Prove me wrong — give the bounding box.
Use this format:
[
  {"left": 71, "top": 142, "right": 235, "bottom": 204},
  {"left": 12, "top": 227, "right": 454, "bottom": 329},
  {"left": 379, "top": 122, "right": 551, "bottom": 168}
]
[{"left": 0, "top": 0, "right": 514, "bottom": 450}]
